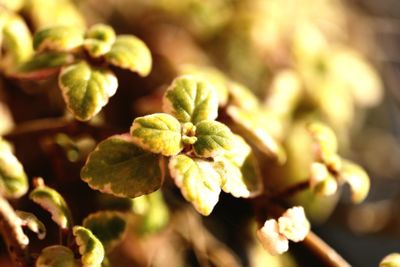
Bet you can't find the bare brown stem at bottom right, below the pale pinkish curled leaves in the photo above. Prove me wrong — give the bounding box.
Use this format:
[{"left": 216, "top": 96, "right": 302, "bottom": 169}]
[{"left": 303, "top": 231, "right": 351, "bottom": 267}]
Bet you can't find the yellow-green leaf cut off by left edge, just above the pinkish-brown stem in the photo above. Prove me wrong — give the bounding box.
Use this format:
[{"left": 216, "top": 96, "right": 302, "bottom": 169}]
[{"left": 0, "top": 137, "right": 28, "bottom": 198}]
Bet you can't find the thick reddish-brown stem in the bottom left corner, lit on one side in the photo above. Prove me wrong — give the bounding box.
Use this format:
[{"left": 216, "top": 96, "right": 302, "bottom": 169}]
[{"left": 0, "top": 196, "right": 29, "bottom": 266}]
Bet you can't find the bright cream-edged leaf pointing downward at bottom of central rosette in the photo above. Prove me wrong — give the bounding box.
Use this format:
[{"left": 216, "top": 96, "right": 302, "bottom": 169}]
[{"left": 168, "top": 155, "right": 221, "bottom": 216}]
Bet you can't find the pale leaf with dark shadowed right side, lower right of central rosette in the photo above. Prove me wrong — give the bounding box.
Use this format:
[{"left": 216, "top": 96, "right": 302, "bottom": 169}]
[{"left": 215, "top": 135, "right": 263, "bottom": 198}]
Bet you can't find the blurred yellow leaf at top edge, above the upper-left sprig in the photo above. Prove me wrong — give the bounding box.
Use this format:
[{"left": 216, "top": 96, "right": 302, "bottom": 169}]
[{"left": 24, "top": 0, "right": 85, "bottom": 30}]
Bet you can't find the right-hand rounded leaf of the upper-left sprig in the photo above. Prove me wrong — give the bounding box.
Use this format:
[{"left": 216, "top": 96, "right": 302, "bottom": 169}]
[{"left": 105, "top": 35, "right": 152, "bottom": 76}]
